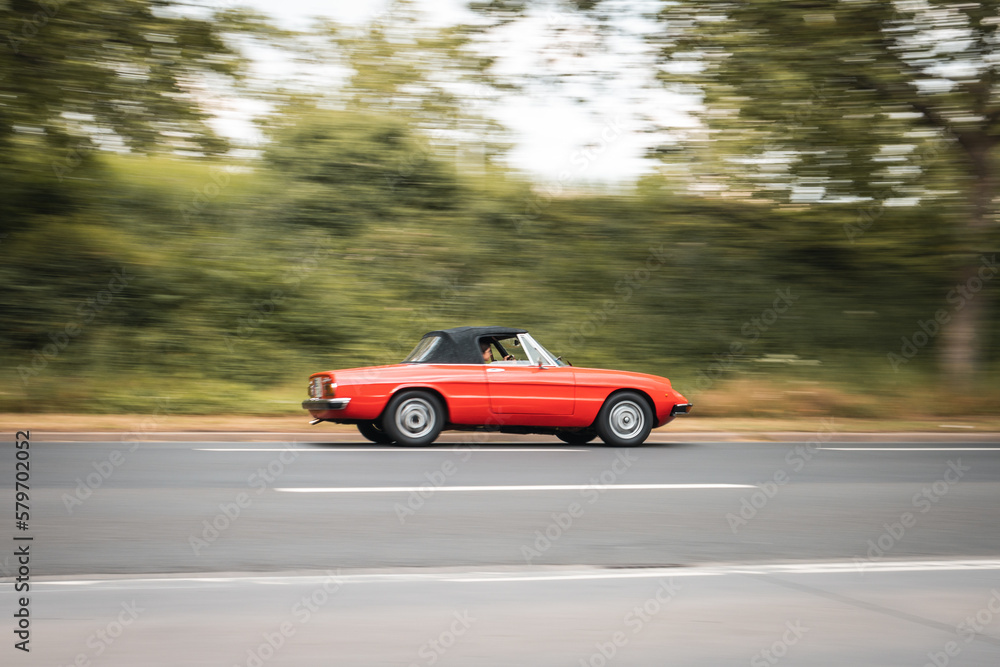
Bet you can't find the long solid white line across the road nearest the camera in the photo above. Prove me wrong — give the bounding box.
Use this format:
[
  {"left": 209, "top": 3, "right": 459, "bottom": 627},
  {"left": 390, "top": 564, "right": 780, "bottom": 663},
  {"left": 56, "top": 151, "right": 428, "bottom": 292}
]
[{"left": 19, "top": 559, "right": 1000, "bottom": 591}]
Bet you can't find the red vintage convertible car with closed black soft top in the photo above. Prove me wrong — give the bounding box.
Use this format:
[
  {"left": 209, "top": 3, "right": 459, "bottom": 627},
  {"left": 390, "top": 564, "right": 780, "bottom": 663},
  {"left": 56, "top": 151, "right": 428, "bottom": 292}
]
[{"left": 302, "top": 327, "right": 691, "bottom": 447}]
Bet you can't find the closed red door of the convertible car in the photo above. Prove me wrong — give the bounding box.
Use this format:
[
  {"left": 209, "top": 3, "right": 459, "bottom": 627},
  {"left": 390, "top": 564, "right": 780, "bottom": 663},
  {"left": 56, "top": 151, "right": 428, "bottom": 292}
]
[{"left": 486, "top": 364, "right": 576, "bottom": 415}]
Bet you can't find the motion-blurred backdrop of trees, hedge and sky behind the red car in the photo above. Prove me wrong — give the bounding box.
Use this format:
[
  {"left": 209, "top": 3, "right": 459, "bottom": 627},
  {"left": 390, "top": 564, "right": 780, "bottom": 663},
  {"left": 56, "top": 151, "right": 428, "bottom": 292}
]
[{"left": 0, "top": 0, "right": 1000, "bottom": 418}]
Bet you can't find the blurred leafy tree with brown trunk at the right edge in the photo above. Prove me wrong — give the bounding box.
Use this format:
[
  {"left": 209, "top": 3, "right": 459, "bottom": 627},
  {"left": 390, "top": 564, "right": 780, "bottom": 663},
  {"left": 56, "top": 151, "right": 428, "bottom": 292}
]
[{"left": 657, "top": 0, "right": 1000, "bottom": 381}]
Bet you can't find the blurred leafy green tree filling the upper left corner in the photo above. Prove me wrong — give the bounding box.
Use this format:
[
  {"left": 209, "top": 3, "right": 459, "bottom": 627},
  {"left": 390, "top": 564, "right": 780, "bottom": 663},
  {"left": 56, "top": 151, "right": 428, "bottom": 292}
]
[{"left": 0, "top": 0, "right": 278, "bottom": 232}]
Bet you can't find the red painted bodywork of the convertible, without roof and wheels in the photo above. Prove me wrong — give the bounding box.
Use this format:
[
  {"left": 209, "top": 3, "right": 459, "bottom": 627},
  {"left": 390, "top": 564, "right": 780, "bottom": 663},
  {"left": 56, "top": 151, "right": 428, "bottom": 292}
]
[{"left": 309, "top": 363, "right": 687, "bottom": 429}]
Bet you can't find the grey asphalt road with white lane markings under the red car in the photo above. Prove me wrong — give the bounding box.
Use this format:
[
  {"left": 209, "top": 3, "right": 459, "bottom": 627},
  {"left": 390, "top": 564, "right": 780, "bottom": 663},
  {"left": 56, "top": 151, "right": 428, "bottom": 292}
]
[{"left": 0, "top": 436, "right": 1000, "bottom": 667}]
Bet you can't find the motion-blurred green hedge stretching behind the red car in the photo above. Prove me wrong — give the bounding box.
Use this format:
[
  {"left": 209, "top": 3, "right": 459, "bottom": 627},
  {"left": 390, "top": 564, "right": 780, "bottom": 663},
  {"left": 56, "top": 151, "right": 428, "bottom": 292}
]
[{"left": 0, "top": 126, "right": 998, "bottom": 413}]
